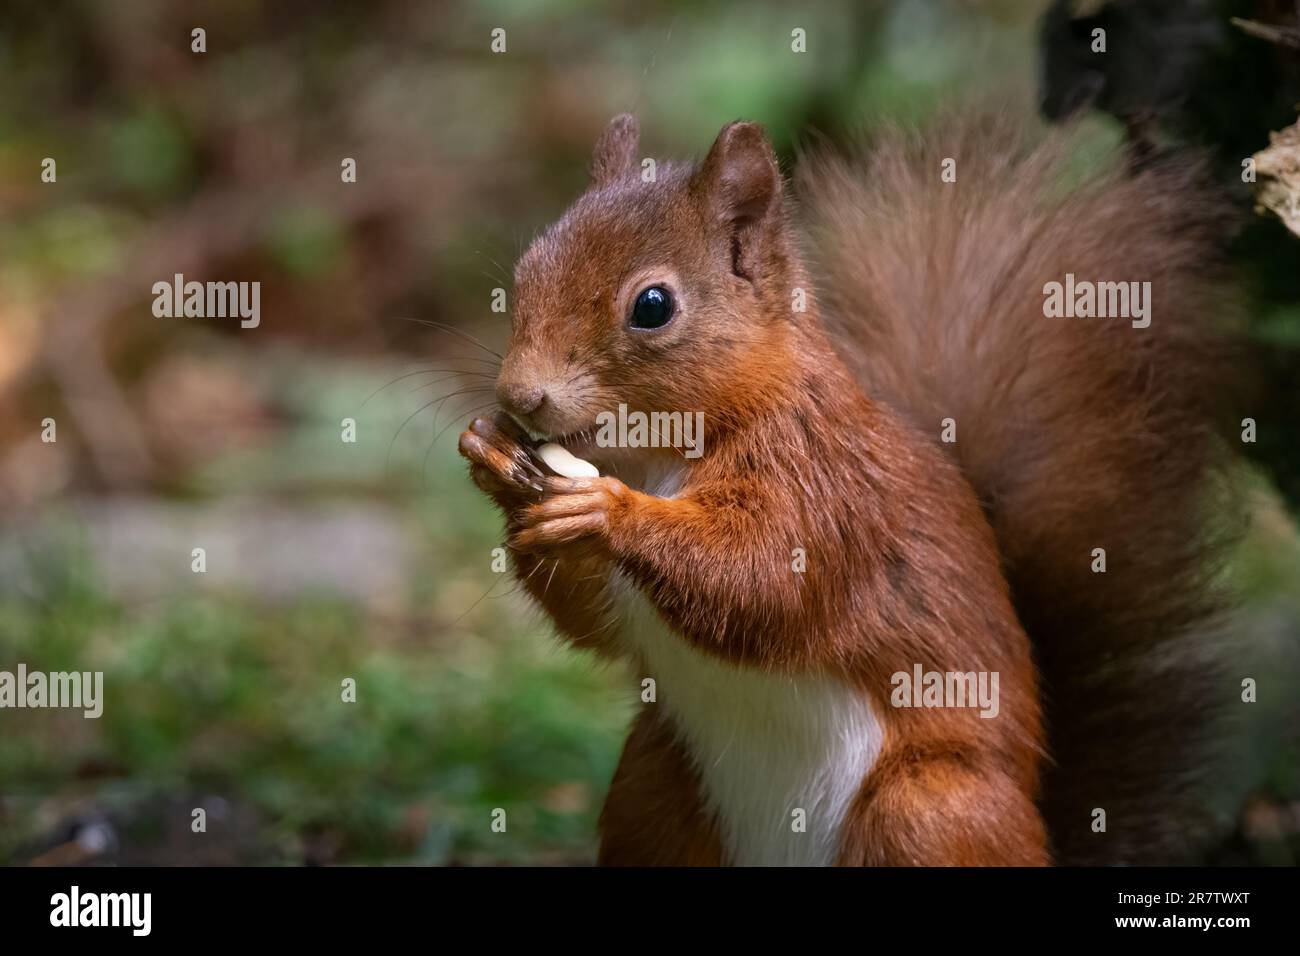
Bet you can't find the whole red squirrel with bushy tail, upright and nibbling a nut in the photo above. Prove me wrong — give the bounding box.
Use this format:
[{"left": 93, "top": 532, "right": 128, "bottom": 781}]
[{"left": 460, "top": 114, "right": 1226, "bottom": 865}]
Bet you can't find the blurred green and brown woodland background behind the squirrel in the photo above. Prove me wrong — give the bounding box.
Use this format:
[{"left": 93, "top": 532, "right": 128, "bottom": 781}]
[{"left": 0, "top": 0, "right": 1300, "bottom": 864}]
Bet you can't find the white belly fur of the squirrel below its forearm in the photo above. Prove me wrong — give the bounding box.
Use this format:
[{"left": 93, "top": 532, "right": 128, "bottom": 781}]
[{"left": 611, "top": 572, "right": 883, "bottom": 866}]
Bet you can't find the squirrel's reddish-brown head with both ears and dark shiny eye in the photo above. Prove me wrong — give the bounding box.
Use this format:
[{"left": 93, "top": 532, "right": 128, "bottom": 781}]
[{"left": 497, "top": 114, "right": 800, "bottom": 457}]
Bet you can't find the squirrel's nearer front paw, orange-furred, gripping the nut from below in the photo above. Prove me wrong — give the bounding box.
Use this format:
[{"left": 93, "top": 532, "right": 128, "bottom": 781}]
[{"left": 508, "top": 476, "right": 631, "bottom": 551}]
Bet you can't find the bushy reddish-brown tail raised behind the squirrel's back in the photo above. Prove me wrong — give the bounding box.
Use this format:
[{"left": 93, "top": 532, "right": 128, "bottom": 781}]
[{"left": 802, "top": 120, "right": 1239, "bottom": 862}]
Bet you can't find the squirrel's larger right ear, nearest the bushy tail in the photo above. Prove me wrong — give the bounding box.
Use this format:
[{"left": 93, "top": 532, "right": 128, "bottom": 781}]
[{"left": 690, "top": 122, "right": 781, "bottom": 278}]
